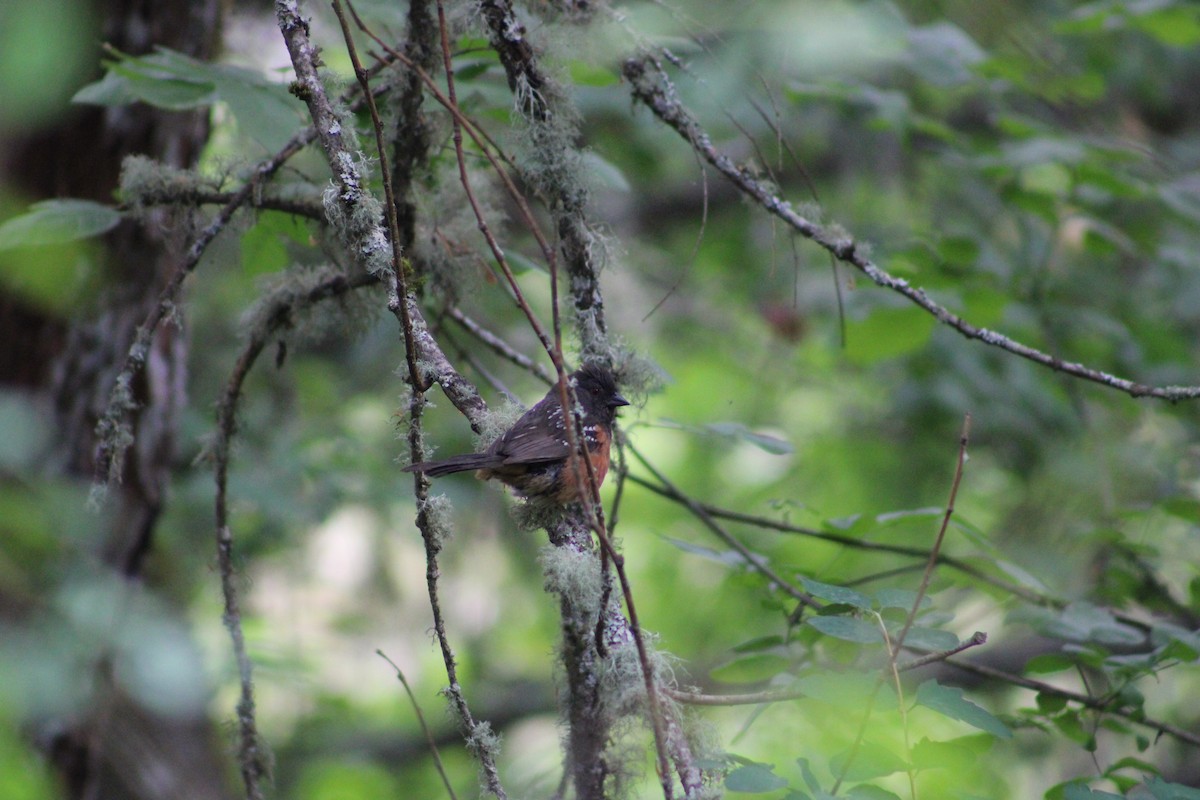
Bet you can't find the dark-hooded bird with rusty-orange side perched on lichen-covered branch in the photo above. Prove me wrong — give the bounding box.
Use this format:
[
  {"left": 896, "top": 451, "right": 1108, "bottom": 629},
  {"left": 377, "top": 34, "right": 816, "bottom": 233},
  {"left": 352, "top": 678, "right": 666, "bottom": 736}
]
[{"left": 404, "top": 365, "right": 629, "bottom": 505}]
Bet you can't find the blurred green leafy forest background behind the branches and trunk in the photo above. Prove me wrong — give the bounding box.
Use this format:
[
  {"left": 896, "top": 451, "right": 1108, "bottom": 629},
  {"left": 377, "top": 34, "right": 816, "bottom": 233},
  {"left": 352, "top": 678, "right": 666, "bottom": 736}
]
[{"left": 0, "top": 0, "right": 1200, "bottom": 800}]
